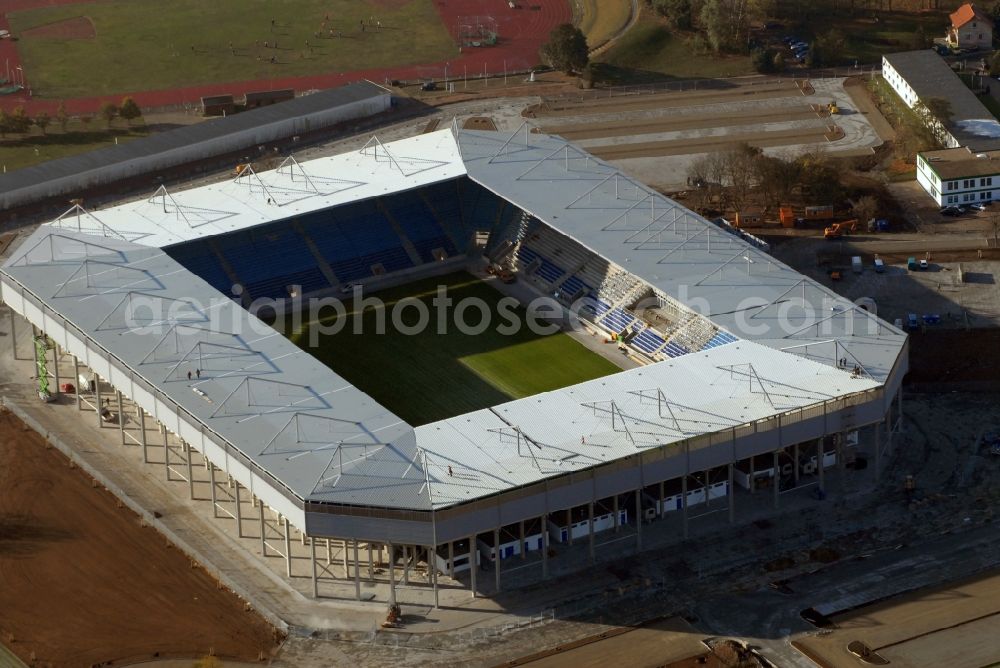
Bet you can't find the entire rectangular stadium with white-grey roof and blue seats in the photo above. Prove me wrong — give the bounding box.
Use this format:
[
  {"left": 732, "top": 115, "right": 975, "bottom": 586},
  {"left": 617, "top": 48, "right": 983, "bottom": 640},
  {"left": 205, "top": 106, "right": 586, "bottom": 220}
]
[{"left": 0, "top": 118, "right": 907, "bottom": 604}]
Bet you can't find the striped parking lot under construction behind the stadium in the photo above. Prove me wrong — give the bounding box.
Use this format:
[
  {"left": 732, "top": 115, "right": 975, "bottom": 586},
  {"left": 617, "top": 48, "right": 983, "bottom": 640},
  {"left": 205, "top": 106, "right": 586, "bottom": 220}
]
[{"left": 524, "top": 77, "right": 885, "bottom": 191}]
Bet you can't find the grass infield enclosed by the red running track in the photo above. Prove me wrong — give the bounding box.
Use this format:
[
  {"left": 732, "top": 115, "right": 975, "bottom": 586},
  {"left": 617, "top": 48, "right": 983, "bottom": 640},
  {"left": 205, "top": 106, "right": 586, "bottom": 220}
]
[{"left": 8, "top": 0, "right": 458, "bottom": 98}]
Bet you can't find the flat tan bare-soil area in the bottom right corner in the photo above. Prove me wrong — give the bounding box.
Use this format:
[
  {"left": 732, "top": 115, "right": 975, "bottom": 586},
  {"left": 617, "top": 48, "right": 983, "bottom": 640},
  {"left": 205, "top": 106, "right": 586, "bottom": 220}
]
[{"left": 795, "top": 575, "right": 1000, "bottom": 668}]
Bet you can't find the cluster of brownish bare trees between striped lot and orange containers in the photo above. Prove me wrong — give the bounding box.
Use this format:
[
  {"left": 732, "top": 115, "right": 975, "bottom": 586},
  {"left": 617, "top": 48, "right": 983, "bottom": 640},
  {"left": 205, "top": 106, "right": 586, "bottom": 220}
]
[{"left": 688, "top": 143, "right": 845, "bottom": 211}]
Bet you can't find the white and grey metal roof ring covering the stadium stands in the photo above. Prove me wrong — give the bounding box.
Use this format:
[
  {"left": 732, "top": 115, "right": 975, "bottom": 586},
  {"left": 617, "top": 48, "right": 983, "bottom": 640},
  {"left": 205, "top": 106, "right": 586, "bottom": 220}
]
[{"left": 2, "top": 130, "right": 906, "bottom": 510}]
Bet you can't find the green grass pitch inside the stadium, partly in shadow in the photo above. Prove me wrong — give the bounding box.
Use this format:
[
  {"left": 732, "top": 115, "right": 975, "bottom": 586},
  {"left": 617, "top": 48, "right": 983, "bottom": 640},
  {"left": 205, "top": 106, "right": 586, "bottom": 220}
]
[{"left": 290, "top": 272, "right": 620, "bottom": 425}]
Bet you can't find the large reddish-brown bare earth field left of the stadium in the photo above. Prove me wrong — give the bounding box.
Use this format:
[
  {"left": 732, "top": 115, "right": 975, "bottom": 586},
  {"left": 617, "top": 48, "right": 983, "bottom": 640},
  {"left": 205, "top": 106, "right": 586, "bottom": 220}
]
[{"left": 0, "top": 412, "right": 278, "bottom": 666}]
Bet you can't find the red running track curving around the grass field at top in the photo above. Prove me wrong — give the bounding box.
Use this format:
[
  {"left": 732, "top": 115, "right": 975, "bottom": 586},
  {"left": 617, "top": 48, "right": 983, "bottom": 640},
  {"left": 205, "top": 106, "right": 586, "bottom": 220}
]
[{"left": 0, "top": 0, "right": 572, "bottom": 114}]
